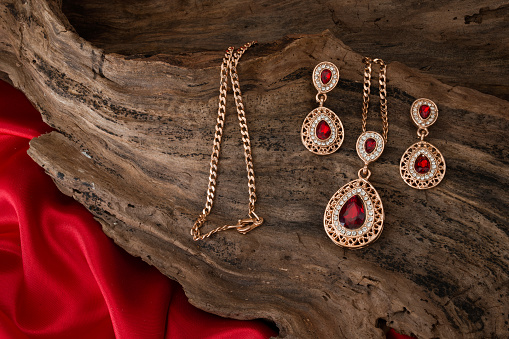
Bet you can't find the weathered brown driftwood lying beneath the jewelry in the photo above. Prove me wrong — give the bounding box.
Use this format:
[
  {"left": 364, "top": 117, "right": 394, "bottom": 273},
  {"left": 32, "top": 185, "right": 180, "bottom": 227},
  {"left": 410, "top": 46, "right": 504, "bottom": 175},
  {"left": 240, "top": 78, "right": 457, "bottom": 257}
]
[{"left": 0, "top": 0, "right": 509, "bottom": 338}]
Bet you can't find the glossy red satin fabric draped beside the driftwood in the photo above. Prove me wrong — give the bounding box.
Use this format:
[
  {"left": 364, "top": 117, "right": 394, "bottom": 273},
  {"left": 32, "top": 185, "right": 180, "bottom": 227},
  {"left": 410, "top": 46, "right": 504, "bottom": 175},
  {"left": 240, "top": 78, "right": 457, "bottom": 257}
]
[{"left": 0, "top": 81, "right": 404, "bottom": 339}]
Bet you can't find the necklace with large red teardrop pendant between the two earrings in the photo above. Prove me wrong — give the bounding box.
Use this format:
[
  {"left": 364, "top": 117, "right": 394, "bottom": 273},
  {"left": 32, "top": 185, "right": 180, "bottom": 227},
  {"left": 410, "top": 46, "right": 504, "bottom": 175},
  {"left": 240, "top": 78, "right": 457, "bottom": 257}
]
[{"left": 323, "top": 58, "right": 389, "bottom": 248}]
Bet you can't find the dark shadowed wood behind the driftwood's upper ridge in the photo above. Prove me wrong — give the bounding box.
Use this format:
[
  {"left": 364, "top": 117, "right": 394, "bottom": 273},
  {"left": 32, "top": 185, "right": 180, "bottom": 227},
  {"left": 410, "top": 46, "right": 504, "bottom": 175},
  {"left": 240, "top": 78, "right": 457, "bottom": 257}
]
[{"left": 59, "top": 0, "right": 509, "bottom": 100}]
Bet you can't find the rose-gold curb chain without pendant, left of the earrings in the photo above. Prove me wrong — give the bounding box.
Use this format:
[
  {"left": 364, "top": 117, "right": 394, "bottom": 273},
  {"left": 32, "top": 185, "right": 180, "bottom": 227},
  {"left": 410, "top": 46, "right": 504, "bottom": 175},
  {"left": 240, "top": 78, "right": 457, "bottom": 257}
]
[{"left": 191, "top": 41, "right": 263, "bottom": 240}]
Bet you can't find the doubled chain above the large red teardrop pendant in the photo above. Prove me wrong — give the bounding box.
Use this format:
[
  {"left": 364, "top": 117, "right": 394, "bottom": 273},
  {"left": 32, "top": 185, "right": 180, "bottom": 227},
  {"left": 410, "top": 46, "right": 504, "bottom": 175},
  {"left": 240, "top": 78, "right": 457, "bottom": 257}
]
[{"left": 362, "top": 57, "right": 389, "bottom": 143}]
